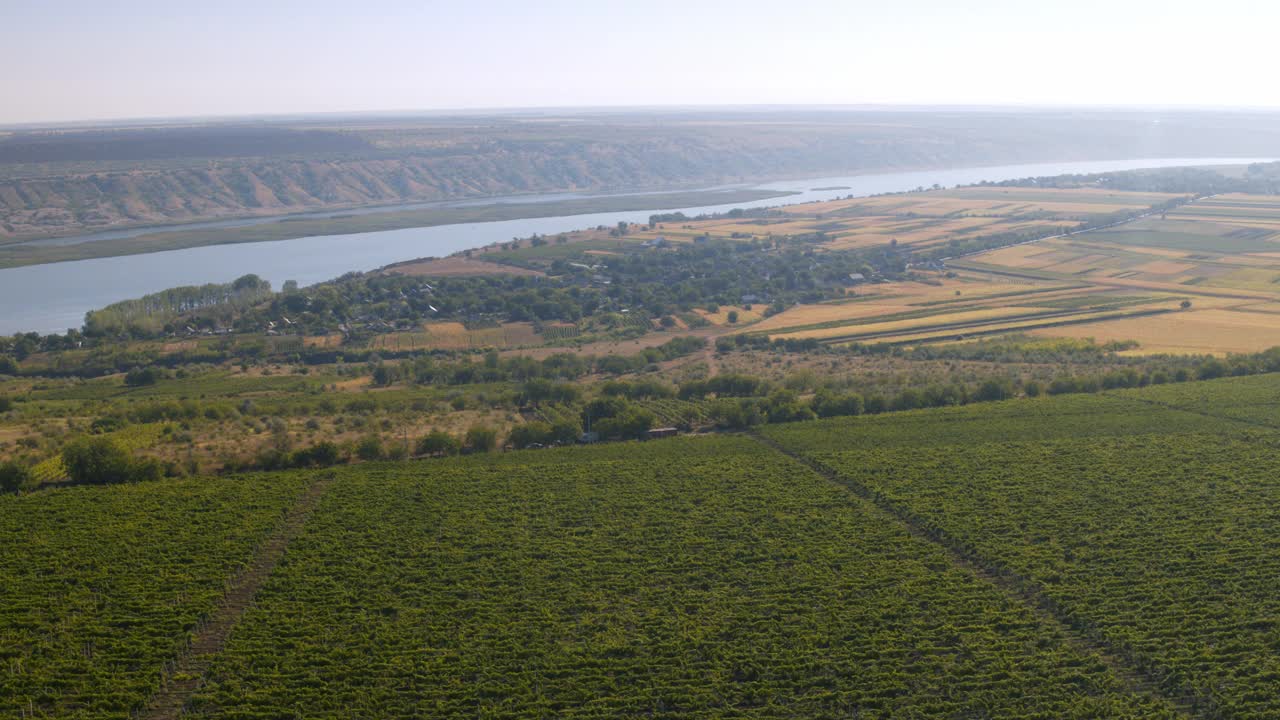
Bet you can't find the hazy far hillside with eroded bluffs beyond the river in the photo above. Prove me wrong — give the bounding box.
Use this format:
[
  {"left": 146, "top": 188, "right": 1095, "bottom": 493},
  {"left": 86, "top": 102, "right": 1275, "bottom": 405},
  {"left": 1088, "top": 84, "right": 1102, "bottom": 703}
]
[{"left": 0, "top": 111, "right": 1280, "bottom": 240}]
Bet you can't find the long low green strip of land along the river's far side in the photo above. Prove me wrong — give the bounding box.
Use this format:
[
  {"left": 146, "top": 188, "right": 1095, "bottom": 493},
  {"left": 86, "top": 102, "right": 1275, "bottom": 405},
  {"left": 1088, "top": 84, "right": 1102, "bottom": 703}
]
[{"left": 0, "top": 188, "right": 799, "bottom": 268}]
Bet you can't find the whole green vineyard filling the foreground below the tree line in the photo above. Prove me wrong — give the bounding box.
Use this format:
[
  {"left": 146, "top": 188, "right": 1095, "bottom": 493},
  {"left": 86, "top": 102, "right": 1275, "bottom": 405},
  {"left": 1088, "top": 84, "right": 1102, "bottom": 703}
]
[{"left": 0, "top": 375, "right": 1280, "bottom": 719}]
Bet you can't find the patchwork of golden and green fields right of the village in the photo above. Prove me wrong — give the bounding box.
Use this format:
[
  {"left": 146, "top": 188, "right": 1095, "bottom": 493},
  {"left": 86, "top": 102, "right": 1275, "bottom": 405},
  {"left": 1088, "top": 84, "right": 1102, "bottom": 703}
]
[{"left": 741, "top": 188, "right": 1280, "bottom": 355}]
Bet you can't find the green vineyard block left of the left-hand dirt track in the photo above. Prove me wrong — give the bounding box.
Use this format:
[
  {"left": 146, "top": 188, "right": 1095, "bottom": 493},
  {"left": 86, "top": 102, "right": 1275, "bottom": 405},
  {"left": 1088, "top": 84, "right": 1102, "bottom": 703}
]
[{"left": 0, "top": 475, "right": 305, "bottom": 719}]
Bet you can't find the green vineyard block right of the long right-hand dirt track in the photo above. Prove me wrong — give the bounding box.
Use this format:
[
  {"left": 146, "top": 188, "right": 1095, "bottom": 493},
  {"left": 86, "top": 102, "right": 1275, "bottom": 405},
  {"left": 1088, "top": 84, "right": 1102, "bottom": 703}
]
[{"left": 771, "top": 375, "right": 1280, "bottom": 719}]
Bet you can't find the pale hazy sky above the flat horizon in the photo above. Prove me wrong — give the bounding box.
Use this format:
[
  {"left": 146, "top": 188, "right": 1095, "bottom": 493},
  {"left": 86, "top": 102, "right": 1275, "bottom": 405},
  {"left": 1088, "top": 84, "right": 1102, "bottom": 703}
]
[{"left": 0, "top": 0, "right": 1280, "bottom": 123}]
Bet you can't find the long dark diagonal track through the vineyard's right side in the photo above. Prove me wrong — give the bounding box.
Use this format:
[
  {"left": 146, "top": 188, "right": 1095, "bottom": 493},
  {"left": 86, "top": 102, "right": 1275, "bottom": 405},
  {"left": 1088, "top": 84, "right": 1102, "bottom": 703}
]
[{"left": 750, "top": 432, "right": 1203, "bottom": 719}]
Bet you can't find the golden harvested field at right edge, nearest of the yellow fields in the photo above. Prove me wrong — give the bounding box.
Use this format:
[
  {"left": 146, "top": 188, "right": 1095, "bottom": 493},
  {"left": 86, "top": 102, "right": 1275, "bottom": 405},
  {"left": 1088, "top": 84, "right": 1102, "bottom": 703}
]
[{"left": 1030, "top": 309, "right": 1280, "bottom": 355}]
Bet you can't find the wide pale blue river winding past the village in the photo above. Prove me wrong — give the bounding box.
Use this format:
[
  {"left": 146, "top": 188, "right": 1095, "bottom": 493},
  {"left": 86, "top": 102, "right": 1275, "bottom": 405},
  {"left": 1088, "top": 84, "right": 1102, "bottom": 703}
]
[{"left": 0, "top": 158, "right": 1266, "bottom": 334}]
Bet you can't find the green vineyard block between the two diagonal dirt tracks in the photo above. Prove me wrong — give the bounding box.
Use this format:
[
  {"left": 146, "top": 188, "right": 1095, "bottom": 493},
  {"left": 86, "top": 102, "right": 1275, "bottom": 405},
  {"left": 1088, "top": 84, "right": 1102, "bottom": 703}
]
[{"left": 192, "top": 438, "right": 1171, "bottom": 719}]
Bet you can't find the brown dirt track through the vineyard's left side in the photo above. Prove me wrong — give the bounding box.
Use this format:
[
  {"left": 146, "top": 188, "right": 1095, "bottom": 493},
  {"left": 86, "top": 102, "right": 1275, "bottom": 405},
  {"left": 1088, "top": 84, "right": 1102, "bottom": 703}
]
[{"left": 132, "top": 471, "right": 335, "bottom": 720}]
